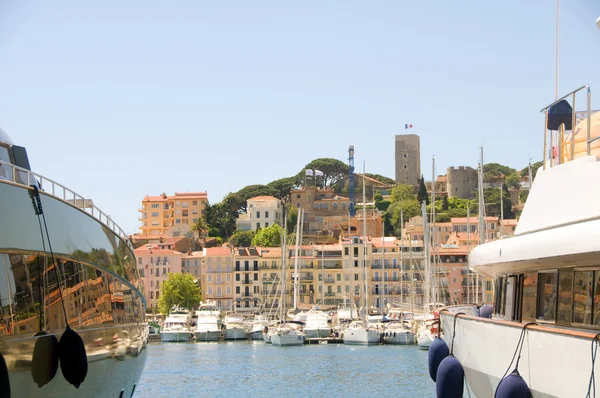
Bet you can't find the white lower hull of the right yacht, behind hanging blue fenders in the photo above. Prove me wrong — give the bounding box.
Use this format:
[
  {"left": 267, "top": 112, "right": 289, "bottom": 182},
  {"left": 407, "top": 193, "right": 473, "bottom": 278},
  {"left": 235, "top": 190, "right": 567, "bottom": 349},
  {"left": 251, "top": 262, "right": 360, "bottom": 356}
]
[{"left": 440, "top": 312, "right": 600, "bottom": 398}]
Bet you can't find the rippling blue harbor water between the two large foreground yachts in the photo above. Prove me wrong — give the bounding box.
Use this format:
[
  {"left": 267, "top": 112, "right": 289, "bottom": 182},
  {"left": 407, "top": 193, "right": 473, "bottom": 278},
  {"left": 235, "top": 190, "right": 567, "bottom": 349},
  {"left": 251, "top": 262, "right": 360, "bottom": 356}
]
[{"left": 135, "top": 341, "right": 435, "bottom": 398}]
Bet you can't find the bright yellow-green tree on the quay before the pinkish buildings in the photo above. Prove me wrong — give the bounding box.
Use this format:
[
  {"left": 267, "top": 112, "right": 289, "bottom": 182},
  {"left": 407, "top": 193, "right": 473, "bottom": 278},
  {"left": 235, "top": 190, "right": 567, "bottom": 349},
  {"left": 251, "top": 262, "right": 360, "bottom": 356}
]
[{"left": 158, "top": 273, "right": 202, "bottom": 314}]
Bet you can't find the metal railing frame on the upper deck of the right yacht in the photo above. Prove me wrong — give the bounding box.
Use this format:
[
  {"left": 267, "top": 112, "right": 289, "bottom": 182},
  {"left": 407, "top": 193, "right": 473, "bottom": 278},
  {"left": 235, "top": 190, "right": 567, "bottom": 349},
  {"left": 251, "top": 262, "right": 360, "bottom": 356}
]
[{"left": 540, "top": 84, "right": 600, "bottom": 170}]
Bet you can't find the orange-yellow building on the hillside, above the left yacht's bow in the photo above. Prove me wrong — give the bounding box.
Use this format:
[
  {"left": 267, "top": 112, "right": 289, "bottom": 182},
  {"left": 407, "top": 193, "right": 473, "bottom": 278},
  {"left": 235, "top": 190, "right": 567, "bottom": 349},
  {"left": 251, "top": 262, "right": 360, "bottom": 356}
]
[{"left": 139, "top": 192, "right": 208, "bottom": 237}]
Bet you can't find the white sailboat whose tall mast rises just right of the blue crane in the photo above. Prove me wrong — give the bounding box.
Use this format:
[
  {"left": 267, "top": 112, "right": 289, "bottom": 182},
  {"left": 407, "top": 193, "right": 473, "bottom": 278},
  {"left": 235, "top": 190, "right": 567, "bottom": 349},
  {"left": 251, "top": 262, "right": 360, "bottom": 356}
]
[{"left": 343, "top": 163, "right": 381, "bottom": 345}]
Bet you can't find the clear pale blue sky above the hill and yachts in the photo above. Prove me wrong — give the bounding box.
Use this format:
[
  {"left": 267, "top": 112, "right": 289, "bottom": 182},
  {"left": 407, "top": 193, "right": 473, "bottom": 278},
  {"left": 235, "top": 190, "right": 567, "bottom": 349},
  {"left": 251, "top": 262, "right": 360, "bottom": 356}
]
[{"left": 0, "top": 0, "right": 600, "bottom": 232}]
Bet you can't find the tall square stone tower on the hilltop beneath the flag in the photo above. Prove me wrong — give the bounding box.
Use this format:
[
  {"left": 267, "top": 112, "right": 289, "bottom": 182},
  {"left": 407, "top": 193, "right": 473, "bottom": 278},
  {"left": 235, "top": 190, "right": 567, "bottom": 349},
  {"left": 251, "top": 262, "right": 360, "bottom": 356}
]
[{"left": 396, "top": 134, "right": 421, "bottom": 185}]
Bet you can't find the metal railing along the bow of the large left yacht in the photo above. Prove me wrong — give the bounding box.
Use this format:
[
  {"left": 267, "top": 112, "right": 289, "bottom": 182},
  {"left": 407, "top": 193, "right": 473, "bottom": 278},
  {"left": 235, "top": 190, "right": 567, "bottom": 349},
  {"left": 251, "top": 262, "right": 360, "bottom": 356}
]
[{"left": 0, "top": 160, "right": 133, "bottom": 250}]
